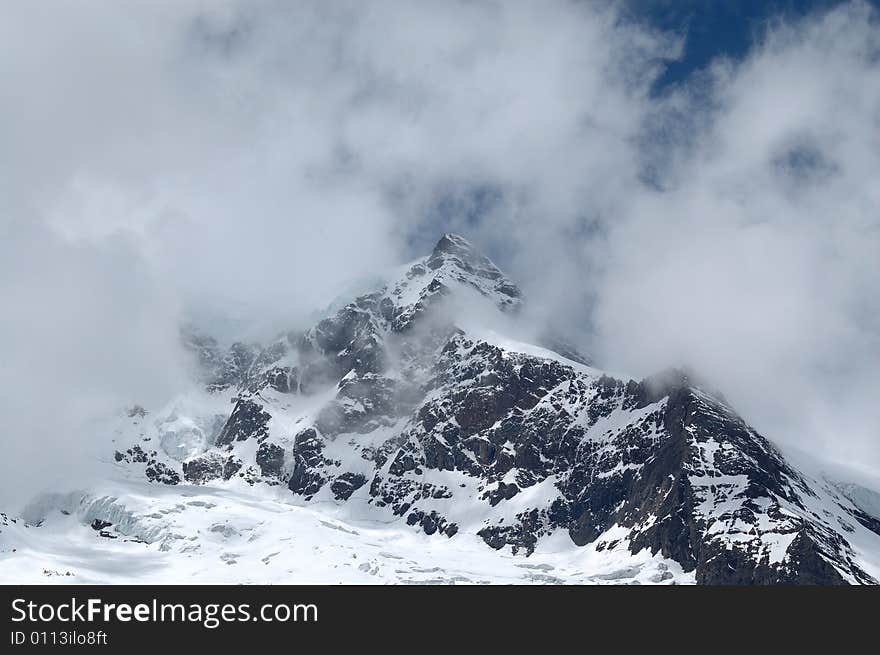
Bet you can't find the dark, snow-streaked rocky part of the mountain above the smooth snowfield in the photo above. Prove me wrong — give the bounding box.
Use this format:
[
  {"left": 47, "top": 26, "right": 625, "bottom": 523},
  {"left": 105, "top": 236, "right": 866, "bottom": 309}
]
[{"left": 117, "top": 235, "right": 880, "bottom": 584}]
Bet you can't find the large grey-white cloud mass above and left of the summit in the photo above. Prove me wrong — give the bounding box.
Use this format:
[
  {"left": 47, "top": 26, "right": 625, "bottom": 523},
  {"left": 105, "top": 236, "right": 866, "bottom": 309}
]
[{"left": 0, "top": 0, "right": 675, "bottom": 508}]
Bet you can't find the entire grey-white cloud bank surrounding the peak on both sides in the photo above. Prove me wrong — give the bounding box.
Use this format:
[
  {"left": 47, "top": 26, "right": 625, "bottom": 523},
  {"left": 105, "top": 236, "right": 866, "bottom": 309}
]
[{"left": 0, "top": 0, "right": 880, "bottom": 508}]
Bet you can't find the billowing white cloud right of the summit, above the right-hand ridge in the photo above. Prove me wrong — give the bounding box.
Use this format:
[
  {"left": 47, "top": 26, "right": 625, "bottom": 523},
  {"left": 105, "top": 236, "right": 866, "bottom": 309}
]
[{"left": 594, "top": 3, "right": 880, "bottom": 472}]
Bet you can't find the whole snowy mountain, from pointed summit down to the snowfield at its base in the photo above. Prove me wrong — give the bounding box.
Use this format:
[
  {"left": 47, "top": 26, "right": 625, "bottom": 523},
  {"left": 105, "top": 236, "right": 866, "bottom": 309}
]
[{"left": 0, "top": 234, "right": 880, "bottom": 584}]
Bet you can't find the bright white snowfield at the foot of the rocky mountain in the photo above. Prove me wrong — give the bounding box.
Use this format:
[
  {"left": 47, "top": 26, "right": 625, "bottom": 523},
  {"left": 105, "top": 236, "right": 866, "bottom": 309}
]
[{"left": 0, "top": 481, "right": 693, "bottom": 584}]
